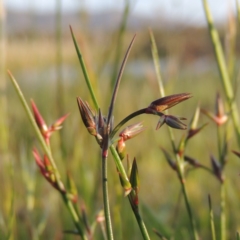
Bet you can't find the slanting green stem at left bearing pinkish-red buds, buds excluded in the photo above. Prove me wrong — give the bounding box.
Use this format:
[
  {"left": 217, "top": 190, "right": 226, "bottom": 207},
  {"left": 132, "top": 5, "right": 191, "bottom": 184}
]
[{"left": 8, "top": 71, "right": 87, "bottom": 240}]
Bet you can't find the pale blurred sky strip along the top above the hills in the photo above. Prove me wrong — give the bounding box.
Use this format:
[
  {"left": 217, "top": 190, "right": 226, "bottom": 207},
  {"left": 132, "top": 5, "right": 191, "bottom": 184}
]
[{"left": 3, "top": 0, "right": 237, "bottom": 25}]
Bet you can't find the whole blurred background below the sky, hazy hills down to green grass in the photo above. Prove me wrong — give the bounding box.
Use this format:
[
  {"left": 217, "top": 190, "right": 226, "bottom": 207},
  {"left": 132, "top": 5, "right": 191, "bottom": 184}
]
[{"left": 0, "top": 0, "right": 240, "bottom": 240}]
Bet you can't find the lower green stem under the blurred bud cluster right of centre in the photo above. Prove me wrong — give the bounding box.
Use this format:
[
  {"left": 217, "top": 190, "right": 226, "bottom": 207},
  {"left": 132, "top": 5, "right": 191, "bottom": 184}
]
[{"left": 176, "top": 155, "right": 198, "bottom": 240}]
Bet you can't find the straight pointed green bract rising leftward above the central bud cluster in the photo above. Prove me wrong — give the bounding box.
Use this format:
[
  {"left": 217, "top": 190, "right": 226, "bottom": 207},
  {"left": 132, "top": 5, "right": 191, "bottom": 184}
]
[{"left": 70, "top": 26, "right": 99, "bottom": 110}]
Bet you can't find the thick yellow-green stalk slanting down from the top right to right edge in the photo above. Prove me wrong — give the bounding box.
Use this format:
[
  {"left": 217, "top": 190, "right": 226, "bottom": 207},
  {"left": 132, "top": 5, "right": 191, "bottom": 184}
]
[{"left": 203, "top": 0, "right": 240, "bottom": 146}]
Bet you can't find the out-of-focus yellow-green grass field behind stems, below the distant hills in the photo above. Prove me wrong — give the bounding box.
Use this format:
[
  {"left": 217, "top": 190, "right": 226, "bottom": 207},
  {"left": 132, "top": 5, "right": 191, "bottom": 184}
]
[{"left": 3, "top": 15, "right": 240, "bottom": 239}]
